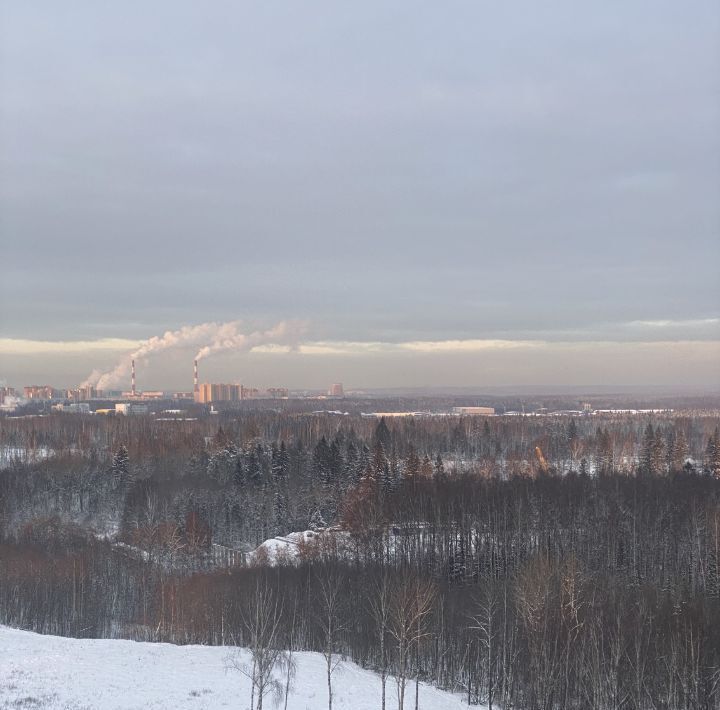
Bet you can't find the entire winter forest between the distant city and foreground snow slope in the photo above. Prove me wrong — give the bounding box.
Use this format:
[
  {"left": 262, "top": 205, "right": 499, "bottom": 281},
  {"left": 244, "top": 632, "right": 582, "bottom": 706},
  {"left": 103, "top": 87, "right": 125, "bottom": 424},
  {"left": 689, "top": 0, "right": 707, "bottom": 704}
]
[{"left": 0, "top": 411, "right": 720, "bottom": 710}]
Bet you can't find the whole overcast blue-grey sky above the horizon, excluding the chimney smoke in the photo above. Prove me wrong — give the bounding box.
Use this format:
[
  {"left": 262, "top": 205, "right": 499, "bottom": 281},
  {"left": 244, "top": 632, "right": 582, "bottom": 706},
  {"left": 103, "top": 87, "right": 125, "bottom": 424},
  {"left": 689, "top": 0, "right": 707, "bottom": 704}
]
[{"left": 0, "top": 0, "right": 720, "bottom": 387}]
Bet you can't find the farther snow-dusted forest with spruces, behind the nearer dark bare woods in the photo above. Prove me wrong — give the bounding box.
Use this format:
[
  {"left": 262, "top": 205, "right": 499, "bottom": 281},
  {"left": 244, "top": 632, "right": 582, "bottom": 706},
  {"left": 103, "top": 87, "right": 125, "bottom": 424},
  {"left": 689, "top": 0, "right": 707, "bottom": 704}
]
[{"left": 0, "top": 412, "right": 720, "bottom": 548}]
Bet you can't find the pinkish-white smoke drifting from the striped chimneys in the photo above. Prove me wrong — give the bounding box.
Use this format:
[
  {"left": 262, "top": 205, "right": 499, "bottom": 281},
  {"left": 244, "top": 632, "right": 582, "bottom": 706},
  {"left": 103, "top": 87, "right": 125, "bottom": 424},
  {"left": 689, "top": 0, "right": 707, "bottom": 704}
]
[{"left": 80, "top": 320, "right": 304, "bottom": 390}]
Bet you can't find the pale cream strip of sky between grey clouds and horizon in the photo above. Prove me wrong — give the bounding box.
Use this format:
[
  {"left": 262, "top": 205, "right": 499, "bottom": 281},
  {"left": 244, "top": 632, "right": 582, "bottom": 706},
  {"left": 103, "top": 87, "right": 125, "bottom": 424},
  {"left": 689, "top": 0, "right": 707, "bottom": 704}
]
[{"left": 3, "top": 330, "right": 720, "bottom": 391}]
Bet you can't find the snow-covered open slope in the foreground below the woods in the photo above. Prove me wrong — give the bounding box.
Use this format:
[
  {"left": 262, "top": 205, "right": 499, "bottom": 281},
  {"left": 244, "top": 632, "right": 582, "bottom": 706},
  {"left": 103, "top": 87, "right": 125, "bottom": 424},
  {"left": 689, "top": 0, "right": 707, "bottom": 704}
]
[{"left": 0, "top": 626, "right": 478, "bottom": 710}]
